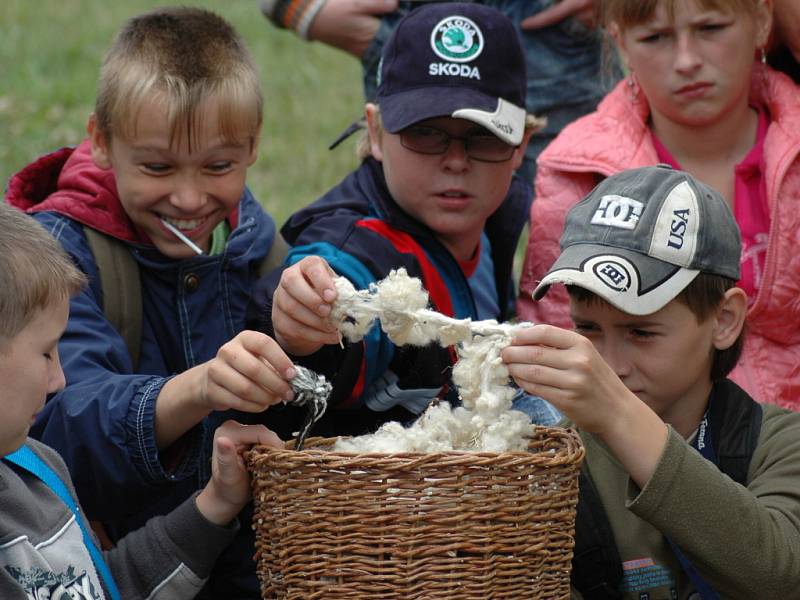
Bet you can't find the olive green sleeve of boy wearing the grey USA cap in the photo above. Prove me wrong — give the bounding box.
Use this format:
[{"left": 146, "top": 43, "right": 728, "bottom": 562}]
[{"left": 628, "top": 407, "right": 800, "bottom": 599}]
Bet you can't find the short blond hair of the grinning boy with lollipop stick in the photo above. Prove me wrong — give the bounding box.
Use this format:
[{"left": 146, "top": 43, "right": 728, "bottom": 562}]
[{"left": 94, "top": 7, "right": 263, "bottom": 151}]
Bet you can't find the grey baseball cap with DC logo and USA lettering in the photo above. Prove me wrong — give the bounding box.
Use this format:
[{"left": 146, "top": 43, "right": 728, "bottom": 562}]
[{"left": 533, "top": 165, "right": 741, "bottom": 315}]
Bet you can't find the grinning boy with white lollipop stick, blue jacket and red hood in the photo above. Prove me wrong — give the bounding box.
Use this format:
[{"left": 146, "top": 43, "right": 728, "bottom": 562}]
[{"left": 7, "top": 8, "right": 293, "bottom": 598}]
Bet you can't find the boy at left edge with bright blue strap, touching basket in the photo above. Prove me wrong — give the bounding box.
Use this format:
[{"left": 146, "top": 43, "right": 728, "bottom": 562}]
[{"left": 0, "top": 204, "right": 280, "bottom": 600}]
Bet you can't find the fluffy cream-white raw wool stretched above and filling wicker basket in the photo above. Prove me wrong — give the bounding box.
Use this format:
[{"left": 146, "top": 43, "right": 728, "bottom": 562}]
[{"left": 331, "top": 269, "right": 530, "bottom": 452}]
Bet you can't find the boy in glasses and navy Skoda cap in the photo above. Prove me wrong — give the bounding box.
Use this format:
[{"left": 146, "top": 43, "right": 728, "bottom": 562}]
[{"left": 254, "top": 3, "right": 557, "bottom": 435}]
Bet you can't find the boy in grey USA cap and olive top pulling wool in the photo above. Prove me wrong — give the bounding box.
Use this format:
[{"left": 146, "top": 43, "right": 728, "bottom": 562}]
[{"left": 503, "top": 165, "right": 800, "bottom": 599}]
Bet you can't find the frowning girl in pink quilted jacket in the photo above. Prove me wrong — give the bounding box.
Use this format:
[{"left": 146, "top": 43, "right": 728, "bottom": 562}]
[{"left": 519, "top": 0, "right": 800, "bottom": 409}]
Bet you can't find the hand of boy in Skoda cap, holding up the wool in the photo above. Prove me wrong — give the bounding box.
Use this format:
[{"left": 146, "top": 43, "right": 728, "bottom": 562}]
[{"left": 272, "top": 256, "right": 339, "bottom": 356}]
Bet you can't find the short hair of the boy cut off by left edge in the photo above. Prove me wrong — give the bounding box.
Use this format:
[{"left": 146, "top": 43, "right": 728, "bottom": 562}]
[{"left": 0, "top": 202, "right": 86, "bottom": 351}]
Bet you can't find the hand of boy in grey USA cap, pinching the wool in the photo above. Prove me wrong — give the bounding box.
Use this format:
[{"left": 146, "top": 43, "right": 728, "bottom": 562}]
[{"left": 502, "top": 325, "right": 639, "bottom": 433}]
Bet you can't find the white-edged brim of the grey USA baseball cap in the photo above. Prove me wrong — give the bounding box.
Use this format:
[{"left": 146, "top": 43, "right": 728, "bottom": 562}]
[{"left": 533, "top": 244, "right": 700, "bottom": 315}]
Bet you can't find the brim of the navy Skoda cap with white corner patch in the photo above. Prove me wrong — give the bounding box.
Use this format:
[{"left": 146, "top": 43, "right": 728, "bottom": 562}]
[{"left": 377, "top": 86, "right": 525, "bottom": 146}]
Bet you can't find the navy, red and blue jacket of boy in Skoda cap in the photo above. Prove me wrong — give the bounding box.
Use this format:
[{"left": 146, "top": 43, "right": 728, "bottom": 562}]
[{"left": 249, "top": 158, "right": 532, "bottom": 435}]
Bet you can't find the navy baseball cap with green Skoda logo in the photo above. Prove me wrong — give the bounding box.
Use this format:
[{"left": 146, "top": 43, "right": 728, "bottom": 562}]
[{"left": 376, "top": 2, "right": 527, "bottom": 146}]
